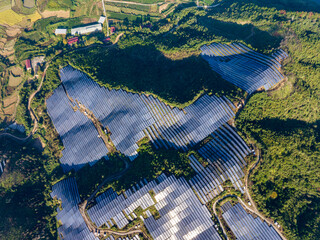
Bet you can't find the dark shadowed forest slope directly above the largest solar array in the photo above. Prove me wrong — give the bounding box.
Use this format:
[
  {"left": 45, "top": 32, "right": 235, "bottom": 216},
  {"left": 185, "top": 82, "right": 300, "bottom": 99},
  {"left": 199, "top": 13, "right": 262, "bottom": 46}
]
[{"left": 64, "top": 45, "right": 242, "bottom": 107}]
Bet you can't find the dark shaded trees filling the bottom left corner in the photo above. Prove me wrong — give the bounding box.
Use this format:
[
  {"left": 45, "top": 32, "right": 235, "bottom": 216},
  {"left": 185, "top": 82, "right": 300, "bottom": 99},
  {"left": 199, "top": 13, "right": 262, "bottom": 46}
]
[{"left": 0, "top": 140, "right": 56, "bottom": 239}]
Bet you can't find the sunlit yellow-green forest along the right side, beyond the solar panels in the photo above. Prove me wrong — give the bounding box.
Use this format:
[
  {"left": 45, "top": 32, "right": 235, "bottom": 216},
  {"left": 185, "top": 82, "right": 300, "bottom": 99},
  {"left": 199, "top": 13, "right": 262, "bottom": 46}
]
[{"left": 230, "top": 1, "right": 320, "bottom": 240}]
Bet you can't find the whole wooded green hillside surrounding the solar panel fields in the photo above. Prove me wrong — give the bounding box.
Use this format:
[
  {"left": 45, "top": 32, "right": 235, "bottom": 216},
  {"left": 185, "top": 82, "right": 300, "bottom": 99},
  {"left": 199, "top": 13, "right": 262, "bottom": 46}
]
[{"left": 0, "top": 0, "right": 320, "bottom": 240}]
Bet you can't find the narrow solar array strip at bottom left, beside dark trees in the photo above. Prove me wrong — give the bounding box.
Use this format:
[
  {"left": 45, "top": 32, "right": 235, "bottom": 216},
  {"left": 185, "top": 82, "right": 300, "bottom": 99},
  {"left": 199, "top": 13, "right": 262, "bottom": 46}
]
[{"left": 50, "top": 178, "right": 97, "bottom": 240}]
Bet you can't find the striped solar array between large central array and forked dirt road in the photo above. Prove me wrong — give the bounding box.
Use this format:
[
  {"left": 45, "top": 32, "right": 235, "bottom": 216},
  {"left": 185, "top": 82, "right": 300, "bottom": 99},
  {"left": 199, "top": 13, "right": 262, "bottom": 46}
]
[{"left": 189, "top": 124, "right": 251, "bottom": 204}]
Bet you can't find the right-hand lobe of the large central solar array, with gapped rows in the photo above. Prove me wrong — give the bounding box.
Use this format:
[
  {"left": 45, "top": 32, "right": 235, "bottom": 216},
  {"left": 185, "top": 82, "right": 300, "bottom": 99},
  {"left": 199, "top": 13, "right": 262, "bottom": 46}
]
[{"left": 142, "top": 95, "right": 234, "bottom": 150}]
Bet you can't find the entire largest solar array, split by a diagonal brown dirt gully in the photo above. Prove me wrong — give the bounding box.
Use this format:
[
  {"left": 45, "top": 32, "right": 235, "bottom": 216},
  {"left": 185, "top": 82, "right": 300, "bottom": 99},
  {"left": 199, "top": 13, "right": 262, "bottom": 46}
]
[{"left": 47, "top": 66, "right": 234, "bottom": 172}]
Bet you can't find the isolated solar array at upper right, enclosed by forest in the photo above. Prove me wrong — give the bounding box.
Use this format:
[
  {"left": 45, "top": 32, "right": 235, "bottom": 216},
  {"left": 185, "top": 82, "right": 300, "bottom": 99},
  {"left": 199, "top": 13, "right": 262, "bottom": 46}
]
[{"left": 201, "top": 43, "right": 288, "bottom": 94}]
